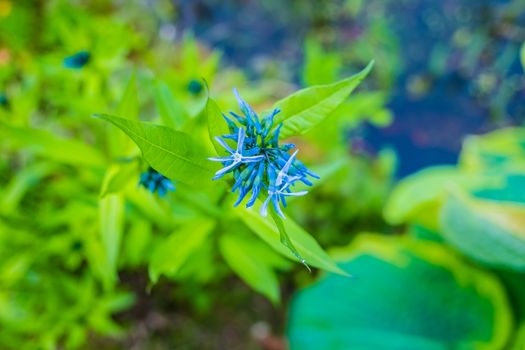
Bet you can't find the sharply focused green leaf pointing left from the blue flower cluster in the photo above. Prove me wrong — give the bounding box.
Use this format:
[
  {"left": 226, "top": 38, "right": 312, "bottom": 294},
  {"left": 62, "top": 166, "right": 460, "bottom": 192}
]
[{"left": 96, "top": 114, "right": 213, "bottom": 186}]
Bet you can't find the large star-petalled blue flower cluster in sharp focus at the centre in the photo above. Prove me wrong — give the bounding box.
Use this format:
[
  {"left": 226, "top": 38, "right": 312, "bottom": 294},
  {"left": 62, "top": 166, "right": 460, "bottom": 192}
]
[{"left": 209, "top": 89, "right": 319, "bottom": 218}]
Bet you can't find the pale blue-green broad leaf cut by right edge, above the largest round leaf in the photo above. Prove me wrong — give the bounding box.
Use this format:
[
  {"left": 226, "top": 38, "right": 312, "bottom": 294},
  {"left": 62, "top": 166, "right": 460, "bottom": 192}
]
[{"left": 441, "top": 193, "right": 525, "bottom": 271}]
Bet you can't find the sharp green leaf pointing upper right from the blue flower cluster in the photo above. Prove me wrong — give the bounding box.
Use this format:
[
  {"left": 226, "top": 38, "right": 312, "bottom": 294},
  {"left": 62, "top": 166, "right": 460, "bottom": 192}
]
[{"left": 274, "top": 61, "right": 374, "bottom": 138}]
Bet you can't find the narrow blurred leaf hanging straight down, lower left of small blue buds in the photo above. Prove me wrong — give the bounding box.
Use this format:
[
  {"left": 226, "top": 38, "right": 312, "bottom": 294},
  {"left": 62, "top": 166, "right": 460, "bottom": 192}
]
[{"left": 99, "top": 195, "right": 124, "bottom": 288}]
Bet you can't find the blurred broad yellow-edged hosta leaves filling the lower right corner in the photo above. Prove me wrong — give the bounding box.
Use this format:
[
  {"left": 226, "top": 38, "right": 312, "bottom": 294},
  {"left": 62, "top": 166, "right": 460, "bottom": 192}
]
[{"left": 289, "top": 128, "right": 525, "bottom": 349}]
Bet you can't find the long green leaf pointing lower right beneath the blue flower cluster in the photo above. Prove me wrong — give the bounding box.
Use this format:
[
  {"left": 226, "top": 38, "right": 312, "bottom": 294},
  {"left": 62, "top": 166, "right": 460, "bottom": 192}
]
[{"left": 233, "top": 202, "right": 347, "bottom": 276}]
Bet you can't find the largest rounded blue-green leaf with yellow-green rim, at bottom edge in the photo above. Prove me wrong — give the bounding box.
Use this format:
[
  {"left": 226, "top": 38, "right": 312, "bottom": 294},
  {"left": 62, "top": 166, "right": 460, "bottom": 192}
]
[{"left": 287, "top": 235, "right": 512, "bottom": 350}]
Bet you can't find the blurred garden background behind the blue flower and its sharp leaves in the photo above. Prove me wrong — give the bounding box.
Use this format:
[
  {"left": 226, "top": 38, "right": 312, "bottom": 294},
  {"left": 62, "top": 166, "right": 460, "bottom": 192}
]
[{"left": 0, "top": 0, "right": 525, "bottom": 349}]
